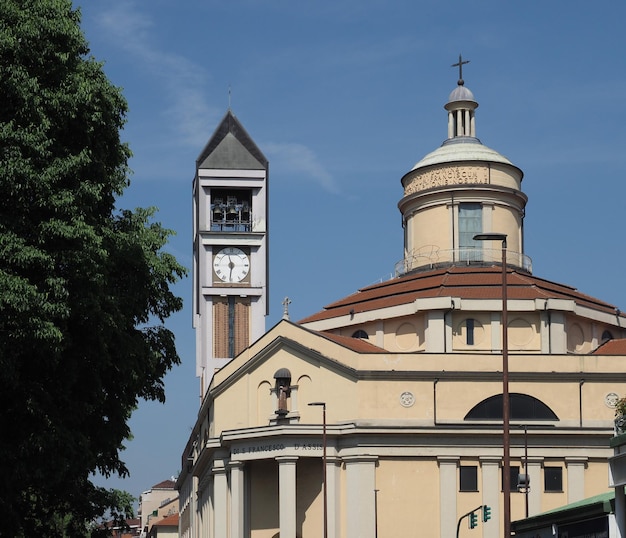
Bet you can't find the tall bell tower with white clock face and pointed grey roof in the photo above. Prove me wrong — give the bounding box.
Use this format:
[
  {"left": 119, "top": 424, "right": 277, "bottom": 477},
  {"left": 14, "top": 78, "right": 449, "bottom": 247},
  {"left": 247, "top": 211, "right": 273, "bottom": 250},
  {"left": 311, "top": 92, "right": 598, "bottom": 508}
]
[{"left": 193, "top": 110, "right": 269, "bottom": 397}]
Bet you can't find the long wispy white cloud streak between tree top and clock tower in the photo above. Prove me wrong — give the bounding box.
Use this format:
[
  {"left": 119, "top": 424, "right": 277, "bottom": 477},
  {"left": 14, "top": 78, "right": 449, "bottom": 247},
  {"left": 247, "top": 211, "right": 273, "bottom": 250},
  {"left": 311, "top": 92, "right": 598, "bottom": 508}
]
[{"left": 92, "top": 1, "right": 219, "bottom": 147}]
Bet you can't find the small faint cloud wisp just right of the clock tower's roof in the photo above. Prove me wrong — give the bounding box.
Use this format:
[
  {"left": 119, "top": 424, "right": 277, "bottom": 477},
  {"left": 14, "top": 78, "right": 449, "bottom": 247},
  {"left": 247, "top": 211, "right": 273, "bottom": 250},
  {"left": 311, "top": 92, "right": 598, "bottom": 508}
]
[{"left": 263, "top": 142, "right": 339, "bottom": 194}]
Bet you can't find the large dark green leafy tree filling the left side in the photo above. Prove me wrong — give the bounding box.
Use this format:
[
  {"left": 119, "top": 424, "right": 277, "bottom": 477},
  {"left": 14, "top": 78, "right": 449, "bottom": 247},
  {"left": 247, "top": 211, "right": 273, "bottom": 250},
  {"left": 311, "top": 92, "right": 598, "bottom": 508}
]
[{"left": 0, "top": 0, "right": 185, "bottom": 537}]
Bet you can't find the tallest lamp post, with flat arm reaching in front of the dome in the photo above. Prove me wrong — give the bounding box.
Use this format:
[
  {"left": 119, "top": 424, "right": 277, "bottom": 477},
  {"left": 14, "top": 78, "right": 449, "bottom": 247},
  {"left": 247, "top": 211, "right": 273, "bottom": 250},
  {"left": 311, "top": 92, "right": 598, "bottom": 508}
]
[{"left": 474, "top": 233, "right": 511, "bottom": 538}]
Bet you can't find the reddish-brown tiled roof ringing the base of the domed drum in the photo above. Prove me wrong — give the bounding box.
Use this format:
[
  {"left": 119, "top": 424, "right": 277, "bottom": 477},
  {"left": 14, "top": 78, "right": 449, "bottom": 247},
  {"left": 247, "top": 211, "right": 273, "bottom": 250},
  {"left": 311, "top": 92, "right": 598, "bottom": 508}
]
[{"left": 299, "top": 266, "right": 626, "bottom": 324}]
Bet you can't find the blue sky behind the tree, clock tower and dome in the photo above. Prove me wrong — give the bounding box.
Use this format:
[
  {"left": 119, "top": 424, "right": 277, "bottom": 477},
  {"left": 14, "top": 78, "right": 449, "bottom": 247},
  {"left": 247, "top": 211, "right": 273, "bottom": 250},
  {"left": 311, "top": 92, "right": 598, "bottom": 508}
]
[{"left": 76, "top": 0, "right": 626, "bottom": 496}]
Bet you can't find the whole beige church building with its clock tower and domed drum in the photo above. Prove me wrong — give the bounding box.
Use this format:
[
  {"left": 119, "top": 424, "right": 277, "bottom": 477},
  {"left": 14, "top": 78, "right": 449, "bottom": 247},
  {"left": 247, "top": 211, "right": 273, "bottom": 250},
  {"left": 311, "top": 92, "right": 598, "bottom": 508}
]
[{"left": 177, "top": 68, "right": 626, "bottom": 538}]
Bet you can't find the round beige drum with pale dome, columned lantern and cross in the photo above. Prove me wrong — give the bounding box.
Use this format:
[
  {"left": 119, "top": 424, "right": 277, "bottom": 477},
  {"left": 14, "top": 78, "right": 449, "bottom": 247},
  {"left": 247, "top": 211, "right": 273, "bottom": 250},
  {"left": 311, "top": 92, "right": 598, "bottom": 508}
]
[{"left": 396, "top": 57, "right": 531, "bottom": 274}]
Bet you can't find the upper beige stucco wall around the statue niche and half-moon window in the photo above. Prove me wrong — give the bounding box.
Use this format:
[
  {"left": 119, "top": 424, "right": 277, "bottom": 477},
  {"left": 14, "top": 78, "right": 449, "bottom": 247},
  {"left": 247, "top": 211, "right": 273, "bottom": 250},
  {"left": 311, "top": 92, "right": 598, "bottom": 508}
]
[{"left": 212, "top": 332, "right": 626, "bottom": 436}]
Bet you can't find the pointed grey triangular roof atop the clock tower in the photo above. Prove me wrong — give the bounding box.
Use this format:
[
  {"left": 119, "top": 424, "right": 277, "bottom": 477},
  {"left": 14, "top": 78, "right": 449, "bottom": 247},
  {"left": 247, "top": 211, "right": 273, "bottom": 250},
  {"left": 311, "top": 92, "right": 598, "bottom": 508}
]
[{"left": 196, "top": 109, "right": 268, "bottom": 170}]
